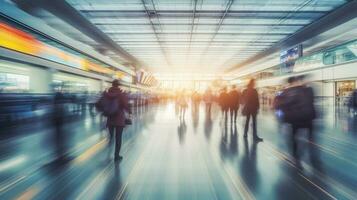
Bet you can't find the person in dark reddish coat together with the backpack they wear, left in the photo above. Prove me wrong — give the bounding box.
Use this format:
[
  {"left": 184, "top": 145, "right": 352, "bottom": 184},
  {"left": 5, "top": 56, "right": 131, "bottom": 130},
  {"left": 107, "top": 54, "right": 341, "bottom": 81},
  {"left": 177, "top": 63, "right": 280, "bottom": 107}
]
[{"left": 97, "top": 80, "right": 131, "bottom": 161}]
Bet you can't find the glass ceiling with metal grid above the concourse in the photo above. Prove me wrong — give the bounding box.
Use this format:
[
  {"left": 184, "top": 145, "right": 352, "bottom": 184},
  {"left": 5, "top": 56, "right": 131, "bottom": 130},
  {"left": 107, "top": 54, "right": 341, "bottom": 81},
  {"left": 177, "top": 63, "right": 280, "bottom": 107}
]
[{"left": 67, "top": 0, "right": 347, "bottom": 74}]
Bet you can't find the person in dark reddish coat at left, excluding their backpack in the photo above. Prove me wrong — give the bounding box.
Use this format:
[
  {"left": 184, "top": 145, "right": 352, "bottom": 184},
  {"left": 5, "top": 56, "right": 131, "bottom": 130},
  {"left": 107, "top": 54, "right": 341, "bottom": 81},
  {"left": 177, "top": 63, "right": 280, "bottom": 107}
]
[{"left": 104, "top": 80, "right": 131, "bottom": 161}]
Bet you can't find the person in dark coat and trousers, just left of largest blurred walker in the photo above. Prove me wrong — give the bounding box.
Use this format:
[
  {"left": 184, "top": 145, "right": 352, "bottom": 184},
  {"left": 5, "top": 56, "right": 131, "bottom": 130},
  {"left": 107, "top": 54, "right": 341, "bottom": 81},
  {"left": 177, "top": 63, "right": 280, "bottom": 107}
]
[{"left": 242, "top": 79, "right": 263, "bottom": 142}]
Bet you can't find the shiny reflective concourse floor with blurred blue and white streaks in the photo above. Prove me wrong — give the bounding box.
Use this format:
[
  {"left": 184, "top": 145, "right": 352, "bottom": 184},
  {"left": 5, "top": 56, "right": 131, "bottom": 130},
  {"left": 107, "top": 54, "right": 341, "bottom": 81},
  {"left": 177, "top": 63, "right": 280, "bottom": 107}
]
[{"left": 0, "top": 103, "right": 357, "bottom": 200}]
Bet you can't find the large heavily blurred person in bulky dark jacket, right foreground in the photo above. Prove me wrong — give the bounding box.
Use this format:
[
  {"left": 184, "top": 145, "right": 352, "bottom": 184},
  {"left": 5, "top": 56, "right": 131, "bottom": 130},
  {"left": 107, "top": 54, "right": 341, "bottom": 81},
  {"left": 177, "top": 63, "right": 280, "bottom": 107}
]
[{"left": 279, "top": 76, "right": 316, "bottom": 158}]
